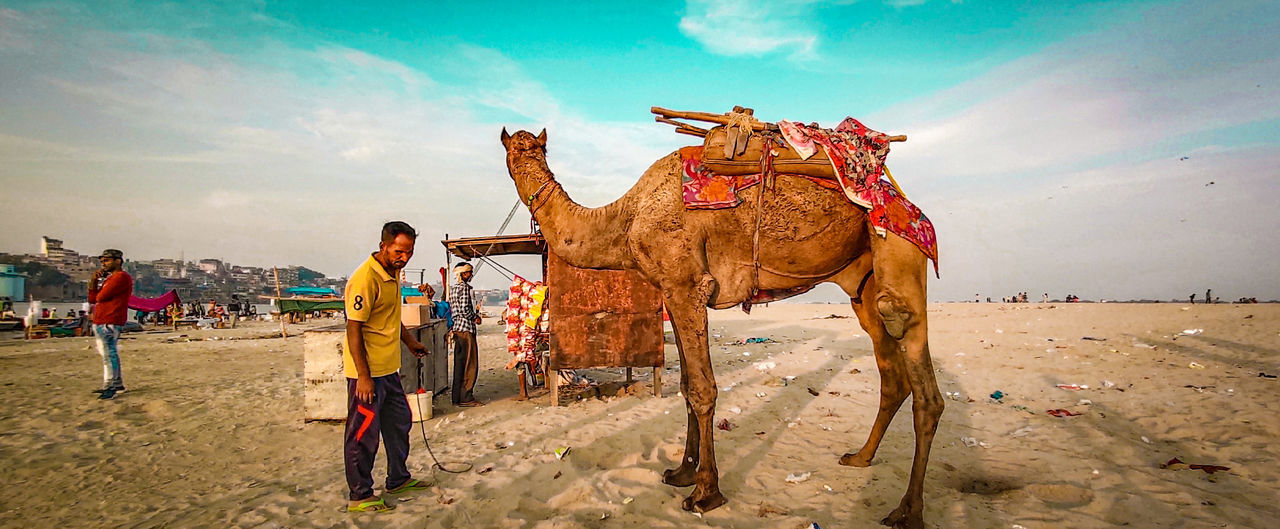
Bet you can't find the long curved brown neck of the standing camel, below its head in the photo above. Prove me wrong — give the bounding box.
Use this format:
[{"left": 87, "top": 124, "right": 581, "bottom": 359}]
[{"left": 507, "top": 151, "right": 634, "bottom": 270}]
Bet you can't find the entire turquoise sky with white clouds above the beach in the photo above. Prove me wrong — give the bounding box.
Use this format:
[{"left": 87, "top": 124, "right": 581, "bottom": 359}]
[{"left": 0, "top": 0, "right": 1280, "bottom": 302}]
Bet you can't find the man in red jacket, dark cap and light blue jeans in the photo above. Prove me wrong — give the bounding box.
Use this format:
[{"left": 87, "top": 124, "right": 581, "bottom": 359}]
[{"left": 88, "top": 250, "right": 133, "bottom": 400}]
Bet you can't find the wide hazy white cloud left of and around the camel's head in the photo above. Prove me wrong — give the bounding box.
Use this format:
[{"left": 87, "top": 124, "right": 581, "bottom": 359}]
[{"left": 0, "top": 8, "right": 669, "bottom": 287}]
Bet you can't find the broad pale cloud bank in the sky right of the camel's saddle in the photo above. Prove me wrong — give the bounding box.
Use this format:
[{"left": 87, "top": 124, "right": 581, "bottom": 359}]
[{"left": 865, "top": 0, "right": 1280, "bottom": 300}]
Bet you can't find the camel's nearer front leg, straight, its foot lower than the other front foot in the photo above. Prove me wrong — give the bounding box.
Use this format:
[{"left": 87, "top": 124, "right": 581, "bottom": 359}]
[{"left": 663, "top": 275, "right": 724, "bottom": 512}]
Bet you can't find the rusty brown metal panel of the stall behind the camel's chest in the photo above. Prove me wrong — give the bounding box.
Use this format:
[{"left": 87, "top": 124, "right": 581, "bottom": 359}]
[{"left": 547, "top": 254, "right": 663, "bottom": 369}]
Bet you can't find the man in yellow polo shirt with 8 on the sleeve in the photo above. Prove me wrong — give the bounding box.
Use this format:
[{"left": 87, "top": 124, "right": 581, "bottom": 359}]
[{"left": 342, "top": 220, "right": 429, "bottom": 512}]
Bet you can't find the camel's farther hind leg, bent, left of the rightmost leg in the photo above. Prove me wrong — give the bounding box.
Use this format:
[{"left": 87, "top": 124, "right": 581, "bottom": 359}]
[{"left": 835, "top": 261, "right": 911, "bottom": 466}]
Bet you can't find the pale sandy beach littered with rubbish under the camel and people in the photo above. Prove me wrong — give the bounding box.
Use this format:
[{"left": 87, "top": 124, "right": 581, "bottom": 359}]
[{"left": 0, "top": 304, "right": 1280, "bottom": 529}]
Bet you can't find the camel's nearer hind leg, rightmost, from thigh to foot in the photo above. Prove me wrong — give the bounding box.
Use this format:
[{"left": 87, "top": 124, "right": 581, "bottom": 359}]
[{"left": 868, "top": 233, "right": 945, "bottom": 529}]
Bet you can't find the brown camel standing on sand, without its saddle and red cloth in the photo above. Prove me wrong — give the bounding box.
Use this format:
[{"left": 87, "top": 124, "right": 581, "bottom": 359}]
[{"left": 502, "top": 128, "right": 943, "bottom": 528}]
